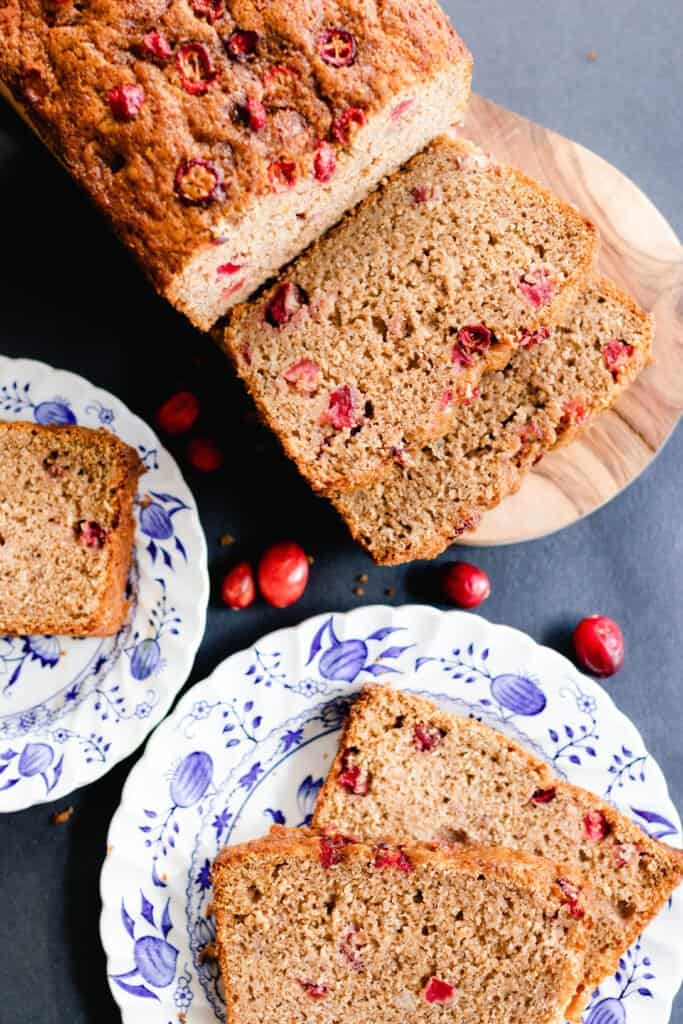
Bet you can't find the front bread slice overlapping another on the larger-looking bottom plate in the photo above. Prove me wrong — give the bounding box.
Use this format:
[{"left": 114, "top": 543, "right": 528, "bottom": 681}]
[{"left": 213, "top": 828, "right": 590, "bottom": 1024}]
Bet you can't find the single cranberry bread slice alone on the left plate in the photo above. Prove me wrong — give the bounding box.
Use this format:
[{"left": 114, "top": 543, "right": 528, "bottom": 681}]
[{"left": 0, "top": 422, "right": 143, "bottom": 637}]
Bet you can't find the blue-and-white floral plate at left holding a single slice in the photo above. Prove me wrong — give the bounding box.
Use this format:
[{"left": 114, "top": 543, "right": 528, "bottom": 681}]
[{"left": 0, "top": 356, "right": 209, "bottom": 811}]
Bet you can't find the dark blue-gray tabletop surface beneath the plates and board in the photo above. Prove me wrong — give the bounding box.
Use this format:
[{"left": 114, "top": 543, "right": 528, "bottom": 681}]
[{"left": 0, "top": 0, "right": 683, "bottom": 1024}]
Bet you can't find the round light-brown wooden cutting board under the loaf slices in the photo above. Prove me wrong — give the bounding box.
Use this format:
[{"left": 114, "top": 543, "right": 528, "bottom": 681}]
[{"left": 459, "top": 96, "right": 683, "bottom": 545}]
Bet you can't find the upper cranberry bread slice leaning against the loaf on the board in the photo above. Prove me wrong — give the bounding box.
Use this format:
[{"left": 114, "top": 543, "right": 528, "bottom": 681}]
[{"left": 219, "top": 137, "right": 597, "bottom": 494}]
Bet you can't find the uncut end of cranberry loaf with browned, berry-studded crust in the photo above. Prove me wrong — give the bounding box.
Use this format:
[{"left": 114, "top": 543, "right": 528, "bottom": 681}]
[{"left": 0, "top": 0, "right": 472, "bottom": 329}]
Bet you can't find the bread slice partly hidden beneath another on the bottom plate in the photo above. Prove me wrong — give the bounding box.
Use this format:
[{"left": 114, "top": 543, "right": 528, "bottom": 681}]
[{"left": 313, "top": 686, "right": 683, "bottom": 1020}]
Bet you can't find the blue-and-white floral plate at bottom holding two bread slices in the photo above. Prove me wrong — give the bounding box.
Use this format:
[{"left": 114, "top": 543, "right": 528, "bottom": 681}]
[{"left": 101, "top": 606, "right": 683, "bottom": 1024}]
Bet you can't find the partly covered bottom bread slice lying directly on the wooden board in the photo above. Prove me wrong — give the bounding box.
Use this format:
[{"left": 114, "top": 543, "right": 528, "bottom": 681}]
[{"left": 333, "top": 276, "right": 654, "bottom": 565}]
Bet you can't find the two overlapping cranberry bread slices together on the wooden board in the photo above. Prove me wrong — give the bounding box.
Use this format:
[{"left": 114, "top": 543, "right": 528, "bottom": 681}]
[{"left": 219, "top": 136, "right": 653, "bottom": 564}]
